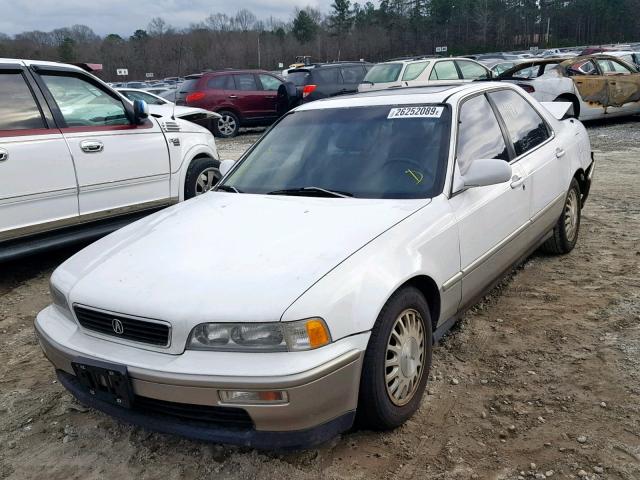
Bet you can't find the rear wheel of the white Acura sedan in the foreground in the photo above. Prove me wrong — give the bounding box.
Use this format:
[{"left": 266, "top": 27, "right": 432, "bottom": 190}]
[{"left": 542, "top": 178, "right": 582, "bottom": 255}]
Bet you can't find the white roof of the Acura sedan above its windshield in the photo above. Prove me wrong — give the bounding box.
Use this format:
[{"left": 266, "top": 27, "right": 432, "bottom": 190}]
[{"left": 296, "top": 81, "right": 504, "bottom": 111}]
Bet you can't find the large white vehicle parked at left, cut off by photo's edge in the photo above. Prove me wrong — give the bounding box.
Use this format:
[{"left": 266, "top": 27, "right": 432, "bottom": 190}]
[{"left": 0, "top": 58, "right": 219, "bottom": 260}]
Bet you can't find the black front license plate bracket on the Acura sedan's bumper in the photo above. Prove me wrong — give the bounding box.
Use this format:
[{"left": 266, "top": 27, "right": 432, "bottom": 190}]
[{"left": 71, "top": 358, "right": 133, "bottom": 408}]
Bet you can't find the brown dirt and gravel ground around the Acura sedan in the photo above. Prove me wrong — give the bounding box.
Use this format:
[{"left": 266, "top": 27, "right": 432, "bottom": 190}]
[{"left": 0, "top": 118, "right": 640, "bottom": 480}]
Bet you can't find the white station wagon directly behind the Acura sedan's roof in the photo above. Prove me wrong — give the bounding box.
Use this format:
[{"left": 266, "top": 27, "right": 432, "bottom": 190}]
[{"left": 358, "top": 57, "right": 491, "bottom": 92}]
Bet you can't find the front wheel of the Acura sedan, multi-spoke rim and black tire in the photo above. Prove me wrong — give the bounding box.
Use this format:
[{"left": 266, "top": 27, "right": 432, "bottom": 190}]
[{"left": 358, "top": 287, "right": 433, "bottom": 430}]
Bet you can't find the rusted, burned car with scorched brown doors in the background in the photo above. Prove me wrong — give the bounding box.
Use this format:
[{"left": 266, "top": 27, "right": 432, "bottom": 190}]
[{"left": 498, "top": 55, "right": 640, "bottom": 120}]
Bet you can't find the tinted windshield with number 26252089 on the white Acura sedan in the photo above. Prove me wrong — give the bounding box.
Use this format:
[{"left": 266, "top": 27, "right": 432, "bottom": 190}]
[{"left": 221, "top": 105, "right": 451, "bottom": 198}]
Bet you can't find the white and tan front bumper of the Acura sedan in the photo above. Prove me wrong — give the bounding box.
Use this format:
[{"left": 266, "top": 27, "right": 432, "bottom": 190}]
[{"left": 35, "top": 307, "right": 368, "bottom": 449}]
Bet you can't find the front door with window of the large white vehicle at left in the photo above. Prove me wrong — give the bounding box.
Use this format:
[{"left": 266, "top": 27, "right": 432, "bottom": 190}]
[{"left": 38, "top": 69, "right": 171, "bottom": 219}]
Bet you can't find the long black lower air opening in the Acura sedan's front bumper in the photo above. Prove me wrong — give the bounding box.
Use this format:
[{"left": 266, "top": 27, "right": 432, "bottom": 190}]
[{"left": 133, "top": 395, "right": 253, "bottom": 429}]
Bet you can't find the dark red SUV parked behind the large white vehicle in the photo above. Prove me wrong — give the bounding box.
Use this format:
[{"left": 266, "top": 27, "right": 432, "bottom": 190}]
[{"left": 176, "top": 70, "right": 296, "bottom": 138}]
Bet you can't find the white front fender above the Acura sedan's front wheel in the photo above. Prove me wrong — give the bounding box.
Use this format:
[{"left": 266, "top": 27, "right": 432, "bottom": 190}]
[{"left": 281, "top": 196, "right": 460, "bottom": 340}]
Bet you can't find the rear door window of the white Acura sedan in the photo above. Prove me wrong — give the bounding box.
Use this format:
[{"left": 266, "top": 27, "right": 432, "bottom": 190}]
[{"left": 489, "top": 90, "right": 550, "bottom": 156}]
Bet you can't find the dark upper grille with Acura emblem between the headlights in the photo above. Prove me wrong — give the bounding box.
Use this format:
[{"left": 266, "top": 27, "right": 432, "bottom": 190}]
[{"left": 74, "top": 306, "right": 170, "bottom": 347}]
